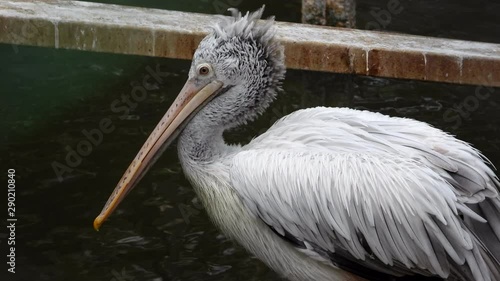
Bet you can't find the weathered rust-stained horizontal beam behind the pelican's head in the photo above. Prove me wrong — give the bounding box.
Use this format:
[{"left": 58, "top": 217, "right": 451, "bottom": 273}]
[{"left": 0, "top": 0, "right": 500, "bottom": 86}]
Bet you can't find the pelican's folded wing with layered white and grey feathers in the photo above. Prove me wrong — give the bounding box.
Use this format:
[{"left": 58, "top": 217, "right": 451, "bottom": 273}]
[{"left": 230, "top": 108, "right": 500, "bottom": 281}]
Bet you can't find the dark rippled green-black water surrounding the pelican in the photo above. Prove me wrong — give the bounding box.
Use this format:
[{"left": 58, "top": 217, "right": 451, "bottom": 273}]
[{"left": 0, "top": 0, "right": 500, "bottom": 281}]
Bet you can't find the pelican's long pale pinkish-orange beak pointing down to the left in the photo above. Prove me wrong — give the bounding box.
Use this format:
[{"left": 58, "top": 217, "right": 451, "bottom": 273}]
[{"left": 94, "top": 79, "right": 223, "bottom": 230}]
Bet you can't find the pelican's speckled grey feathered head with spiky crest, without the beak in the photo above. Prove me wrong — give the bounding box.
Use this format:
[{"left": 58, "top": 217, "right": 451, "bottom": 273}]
[{"left": 187, "top": 7, "right": 285, "bottom": 129}]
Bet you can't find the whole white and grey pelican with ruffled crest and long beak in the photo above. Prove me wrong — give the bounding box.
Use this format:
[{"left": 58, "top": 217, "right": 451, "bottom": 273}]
[{"left": 94, "top": 7, "right": 500, "bottom": 281}]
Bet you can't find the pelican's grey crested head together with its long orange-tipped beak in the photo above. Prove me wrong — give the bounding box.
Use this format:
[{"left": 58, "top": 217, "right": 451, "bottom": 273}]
[{"left": 94, "top": 7, "right": 285, "bottom": 230}]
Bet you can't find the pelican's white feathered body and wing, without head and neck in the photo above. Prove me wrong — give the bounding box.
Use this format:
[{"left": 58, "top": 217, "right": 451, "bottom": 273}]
[{"left": 179, "top": 108, "right": 500, "bottom": 280}]
